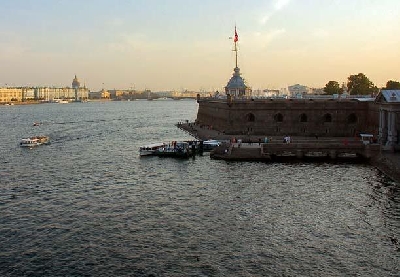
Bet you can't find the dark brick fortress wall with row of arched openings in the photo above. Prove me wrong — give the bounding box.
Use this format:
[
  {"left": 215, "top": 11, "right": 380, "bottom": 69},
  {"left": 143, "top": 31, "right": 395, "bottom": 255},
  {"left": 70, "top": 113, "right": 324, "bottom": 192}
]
[{"left": 197, "top": 99, "right": 379, "bottom": 137}]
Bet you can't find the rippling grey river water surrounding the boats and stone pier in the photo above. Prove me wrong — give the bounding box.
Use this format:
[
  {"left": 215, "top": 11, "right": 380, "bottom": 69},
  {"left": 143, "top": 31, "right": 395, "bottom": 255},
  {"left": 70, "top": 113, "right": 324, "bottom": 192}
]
[{"left": 0, "top": 100, "right": 400, "bottom": 276}]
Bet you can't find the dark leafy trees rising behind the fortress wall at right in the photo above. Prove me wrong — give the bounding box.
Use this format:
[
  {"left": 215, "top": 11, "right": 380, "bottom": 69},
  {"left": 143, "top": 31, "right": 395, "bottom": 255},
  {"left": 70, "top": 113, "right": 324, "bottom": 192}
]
[{"left": 324, "top": 73, "right": 400, "bottom": 95}]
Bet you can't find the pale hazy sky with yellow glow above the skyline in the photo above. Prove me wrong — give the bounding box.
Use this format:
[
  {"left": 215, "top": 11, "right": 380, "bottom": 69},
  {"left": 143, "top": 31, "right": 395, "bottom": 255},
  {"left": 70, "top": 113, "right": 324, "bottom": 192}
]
[{"left": 0, "top": 0, "right": 400, "bottom": 91}]
